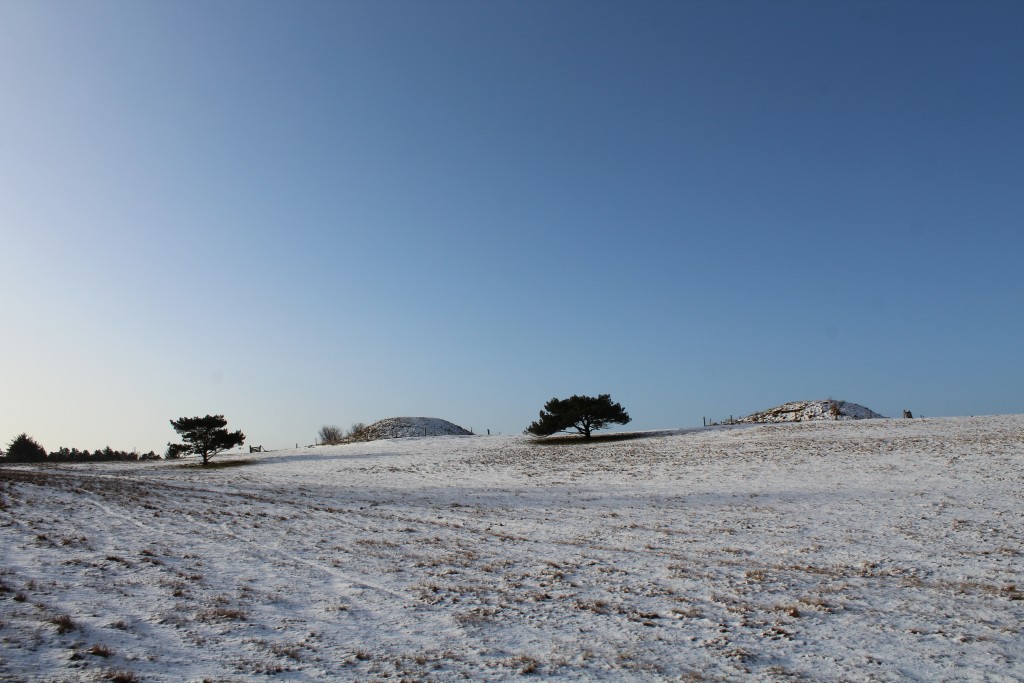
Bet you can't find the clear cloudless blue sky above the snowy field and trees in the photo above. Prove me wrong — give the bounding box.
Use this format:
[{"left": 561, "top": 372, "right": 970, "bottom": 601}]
[{"left": 0, "top": 0, "right": 1024, "bottom": 451}]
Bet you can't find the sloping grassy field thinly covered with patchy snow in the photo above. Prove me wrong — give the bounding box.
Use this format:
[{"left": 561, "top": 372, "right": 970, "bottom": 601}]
[{"left": 0, "top": 416, "right": 1024, "bottom": 681}]
